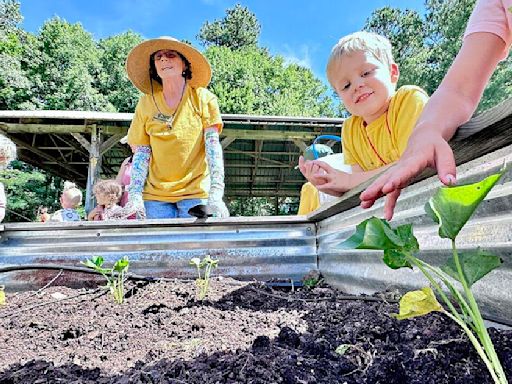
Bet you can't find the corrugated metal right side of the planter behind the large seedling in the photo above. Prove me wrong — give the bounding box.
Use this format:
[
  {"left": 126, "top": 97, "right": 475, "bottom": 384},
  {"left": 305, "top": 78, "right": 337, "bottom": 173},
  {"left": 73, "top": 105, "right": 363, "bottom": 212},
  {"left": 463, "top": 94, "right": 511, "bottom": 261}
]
[{"left": 317, "top": 147, "right": 512, "bottom": 322}]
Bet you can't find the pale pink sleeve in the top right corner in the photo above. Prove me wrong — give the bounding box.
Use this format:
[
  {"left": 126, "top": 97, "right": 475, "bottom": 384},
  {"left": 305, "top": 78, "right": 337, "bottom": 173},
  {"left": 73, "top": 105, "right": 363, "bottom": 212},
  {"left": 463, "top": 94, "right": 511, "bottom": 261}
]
[{"left": 464, "top": 0, "right": 512, "bottom": 59}]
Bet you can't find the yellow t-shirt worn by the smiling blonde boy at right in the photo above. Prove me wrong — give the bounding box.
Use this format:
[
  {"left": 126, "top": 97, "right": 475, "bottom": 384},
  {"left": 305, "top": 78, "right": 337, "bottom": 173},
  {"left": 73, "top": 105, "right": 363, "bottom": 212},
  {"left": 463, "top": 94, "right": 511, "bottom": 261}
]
[{"left": 341, "top": 85, "right": 428, "bottom": 171}]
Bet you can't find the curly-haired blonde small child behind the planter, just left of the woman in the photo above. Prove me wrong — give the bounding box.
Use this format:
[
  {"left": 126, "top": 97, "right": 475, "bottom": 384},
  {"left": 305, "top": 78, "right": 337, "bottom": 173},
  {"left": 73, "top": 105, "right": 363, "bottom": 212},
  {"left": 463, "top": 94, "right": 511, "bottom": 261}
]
[{"left": 87, "top": 180, "right": 127, "bottom": 221}]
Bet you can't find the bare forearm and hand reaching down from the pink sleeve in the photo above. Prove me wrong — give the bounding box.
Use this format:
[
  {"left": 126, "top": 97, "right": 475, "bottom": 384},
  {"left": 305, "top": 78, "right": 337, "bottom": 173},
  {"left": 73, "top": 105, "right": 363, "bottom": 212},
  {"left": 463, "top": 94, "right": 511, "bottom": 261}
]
[{"left": 361, "top": 32, "right": 505, "bottom": 220}]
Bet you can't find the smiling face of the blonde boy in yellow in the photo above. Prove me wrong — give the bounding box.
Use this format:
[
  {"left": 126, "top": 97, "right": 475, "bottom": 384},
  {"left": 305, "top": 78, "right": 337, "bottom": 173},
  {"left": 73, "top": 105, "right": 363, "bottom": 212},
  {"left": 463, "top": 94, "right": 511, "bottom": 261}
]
[{"left": 332, "top": 51, "right": 399, "bottom": 124}]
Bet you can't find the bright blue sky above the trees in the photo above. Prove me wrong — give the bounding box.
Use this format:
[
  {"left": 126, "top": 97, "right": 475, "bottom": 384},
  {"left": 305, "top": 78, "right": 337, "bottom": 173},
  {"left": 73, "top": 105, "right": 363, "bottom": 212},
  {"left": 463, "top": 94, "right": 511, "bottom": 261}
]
[{"left": 20, "top": 0, "right": 424, "bottom": 86}]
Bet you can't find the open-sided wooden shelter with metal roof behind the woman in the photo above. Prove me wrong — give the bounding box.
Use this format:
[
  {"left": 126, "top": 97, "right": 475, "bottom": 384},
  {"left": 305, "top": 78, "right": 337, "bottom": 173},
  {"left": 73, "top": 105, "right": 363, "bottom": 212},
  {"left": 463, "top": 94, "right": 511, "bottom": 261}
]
[{"left": 0, "top": 111, "right": 343, "bottom": 210}]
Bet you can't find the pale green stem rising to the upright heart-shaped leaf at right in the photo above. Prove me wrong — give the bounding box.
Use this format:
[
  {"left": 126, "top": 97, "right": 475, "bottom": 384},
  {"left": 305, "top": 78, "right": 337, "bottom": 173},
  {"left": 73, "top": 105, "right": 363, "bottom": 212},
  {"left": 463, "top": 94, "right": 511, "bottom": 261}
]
[{"left": 452, "top": 240, "right": 508, "bottom": 383}]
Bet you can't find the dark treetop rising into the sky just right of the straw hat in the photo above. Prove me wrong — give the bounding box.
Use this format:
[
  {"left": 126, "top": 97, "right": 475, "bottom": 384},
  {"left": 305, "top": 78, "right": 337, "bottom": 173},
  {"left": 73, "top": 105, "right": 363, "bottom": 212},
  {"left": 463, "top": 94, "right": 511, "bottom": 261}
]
[{"left": 197, "top": 4, "right": 261, "bottom": 49}]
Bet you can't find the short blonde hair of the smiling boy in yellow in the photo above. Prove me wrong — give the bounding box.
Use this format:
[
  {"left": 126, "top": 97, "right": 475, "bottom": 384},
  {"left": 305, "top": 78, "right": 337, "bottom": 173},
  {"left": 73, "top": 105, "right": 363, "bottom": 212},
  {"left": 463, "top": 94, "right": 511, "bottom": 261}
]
[{"left": 327, "top": 31, "right": 394, "bottom": 85}]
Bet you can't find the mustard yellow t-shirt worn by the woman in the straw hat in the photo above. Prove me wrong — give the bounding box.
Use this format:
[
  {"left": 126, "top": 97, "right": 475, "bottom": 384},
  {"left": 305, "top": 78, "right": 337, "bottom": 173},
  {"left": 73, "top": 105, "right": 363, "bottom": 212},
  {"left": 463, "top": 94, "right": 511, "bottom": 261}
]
[{"left": 128, "top": 84, "right": 222, "bottom": 203}]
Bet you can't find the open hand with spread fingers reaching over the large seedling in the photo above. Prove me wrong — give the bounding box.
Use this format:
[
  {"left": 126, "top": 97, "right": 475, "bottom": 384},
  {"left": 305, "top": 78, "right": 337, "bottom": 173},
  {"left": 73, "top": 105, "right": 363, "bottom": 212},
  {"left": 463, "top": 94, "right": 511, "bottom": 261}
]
[{"left": 360, "top": 130, "right": 456, "bottom": 220}]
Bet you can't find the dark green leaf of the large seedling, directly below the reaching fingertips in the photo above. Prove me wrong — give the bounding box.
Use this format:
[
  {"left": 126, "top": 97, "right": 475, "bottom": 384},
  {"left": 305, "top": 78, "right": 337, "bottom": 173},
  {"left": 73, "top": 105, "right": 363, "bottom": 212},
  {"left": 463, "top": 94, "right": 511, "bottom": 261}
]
[{"left": 336, "top": 217, "right": 404, "bottom": 250}]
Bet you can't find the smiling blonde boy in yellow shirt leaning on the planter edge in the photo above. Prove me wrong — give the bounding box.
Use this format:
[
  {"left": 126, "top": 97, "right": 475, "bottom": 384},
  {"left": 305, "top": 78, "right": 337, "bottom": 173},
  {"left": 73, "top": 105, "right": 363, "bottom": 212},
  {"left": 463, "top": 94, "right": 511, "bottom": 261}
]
[{"left": 299, "top": 32, "right": 428, "bottom": 196}]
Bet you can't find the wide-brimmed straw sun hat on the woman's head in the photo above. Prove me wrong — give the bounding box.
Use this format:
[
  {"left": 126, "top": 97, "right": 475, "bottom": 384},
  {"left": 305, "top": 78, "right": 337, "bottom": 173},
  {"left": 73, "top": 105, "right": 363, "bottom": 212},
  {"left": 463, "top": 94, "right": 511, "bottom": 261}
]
[{"left": 126, "top": 36, "right": 212, "bottom": 94}]
